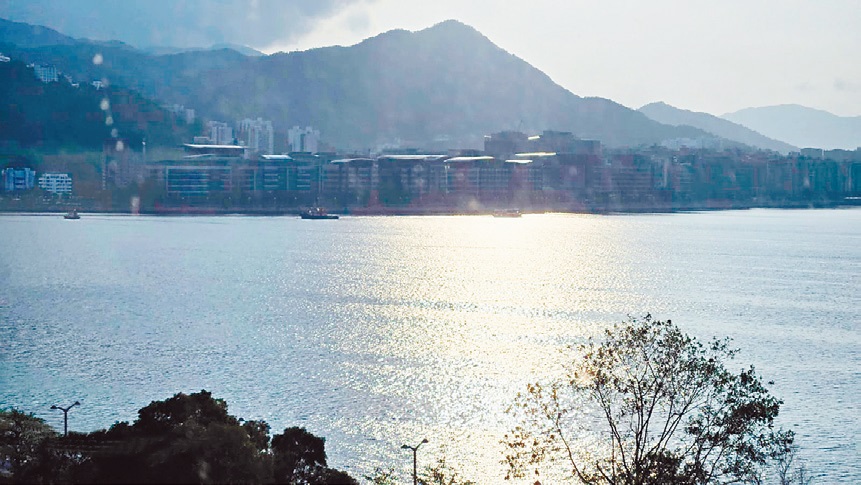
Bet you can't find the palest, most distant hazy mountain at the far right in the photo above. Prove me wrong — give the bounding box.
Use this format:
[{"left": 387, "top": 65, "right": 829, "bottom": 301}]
[{"left": 722, "top": 104, "right": 861, "bottom": 150}]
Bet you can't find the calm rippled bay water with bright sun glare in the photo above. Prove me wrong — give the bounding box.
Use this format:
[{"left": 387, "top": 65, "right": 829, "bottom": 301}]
[{"left": 0, "top": 210, "right": 861, "bottom": 483}]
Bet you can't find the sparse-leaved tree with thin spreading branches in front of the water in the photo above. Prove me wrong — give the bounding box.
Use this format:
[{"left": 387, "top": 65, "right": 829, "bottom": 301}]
[{"left": 503, "top": 315, "right": 793, "bottom": 484}]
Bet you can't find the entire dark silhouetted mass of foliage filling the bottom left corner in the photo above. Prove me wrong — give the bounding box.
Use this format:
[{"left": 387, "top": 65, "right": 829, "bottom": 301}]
[{"left": 0, "top": 391, "right": 358, "bottom": 485}]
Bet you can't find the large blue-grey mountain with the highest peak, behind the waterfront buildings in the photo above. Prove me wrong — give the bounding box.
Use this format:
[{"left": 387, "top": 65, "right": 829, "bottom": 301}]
[{"left": 1, "top": 17, "right": 708, "bottom": 149}]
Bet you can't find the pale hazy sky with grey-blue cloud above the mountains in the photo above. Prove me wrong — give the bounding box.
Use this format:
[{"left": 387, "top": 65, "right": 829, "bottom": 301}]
[{"left": 0, "top": 0, "right": 861, "bottom": 116}]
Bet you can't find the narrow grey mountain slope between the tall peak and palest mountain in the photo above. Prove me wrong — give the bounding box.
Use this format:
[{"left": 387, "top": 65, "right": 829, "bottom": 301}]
[{"left": 638, "top": 102, "right": 798, "bottom": 154}]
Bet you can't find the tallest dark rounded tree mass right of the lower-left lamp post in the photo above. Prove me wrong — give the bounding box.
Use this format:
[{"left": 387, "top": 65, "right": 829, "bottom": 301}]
[{"left": 65, "top": 391, "right": 271, "bottom": 483}]
